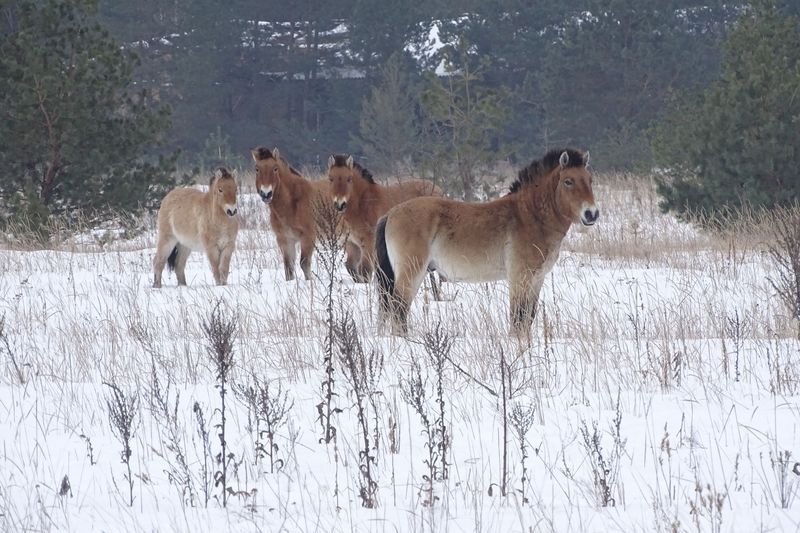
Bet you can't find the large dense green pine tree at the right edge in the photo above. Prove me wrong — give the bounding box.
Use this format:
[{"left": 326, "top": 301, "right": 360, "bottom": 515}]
[{"left": 654, "top": 0, "right": 800, "bottom": 215}]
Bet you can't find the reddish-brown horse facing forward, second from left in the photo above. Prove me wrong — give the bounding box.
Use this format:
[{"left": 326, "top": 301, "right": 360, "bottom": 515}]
[{"left": 250, "top": 146, "right": 328, "bottom": 281}]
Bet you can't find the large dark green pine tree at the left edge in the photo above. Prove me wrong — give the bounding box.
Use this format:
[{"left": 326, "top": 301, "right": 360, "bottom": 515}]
[{"left": 0, "top": 0, "right": 174, "bottom": 230}]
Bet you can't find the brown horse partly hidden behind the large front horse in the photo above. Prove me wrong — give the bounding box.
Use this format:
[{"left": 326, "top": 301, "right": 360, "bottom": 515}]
[{"left": 328, "top": 155, "right": 442, "bottom": 283}]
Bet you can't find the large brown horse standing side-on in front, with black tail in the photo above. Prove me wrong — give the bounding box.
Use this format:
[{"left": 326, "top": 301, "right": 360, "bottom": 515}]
[{"left": 376, "top": 149, "right": 600, "bottom": 337}]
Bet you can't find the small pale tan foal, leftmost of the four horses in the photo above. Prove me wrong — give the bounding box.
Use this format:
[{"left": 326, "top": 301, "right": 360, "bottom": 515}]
[{"left": 153, "top": 168, "right": 239, "bottom": 288}]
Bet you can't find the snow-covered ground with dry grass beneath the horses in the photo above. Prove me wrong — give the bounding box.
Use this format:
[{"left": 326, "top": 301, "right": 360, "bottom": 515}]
[{"left": 0, "top": 179, "right": 800, "bottom": 532}]
